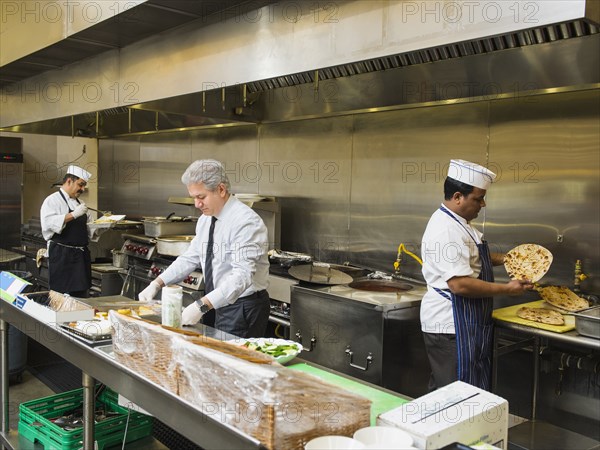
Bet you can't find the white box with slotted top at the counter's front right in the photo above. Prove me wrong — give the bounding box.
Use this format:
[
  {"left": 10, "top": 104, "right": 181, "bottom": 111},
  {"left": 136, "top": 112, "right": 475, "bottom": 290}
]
[{"left": 377, "top": 381, "right": 508, "bottom": 450}]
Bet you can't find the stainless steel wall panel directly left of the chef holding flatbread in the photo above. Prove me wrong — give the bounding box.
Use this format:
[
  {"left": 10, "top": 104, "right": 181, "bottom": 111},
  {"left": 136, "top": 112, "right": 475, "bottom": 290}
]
[{"left": 350, "top": 103, "right": 488, "bottom": 275}]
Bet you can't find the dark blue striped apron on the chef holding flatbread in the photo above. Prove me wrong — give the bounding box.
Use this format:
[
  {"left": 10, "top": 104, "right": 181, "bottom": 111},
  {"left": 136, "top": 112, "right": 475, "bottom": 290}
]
[{"left": 435, "top": 206, "right": 494, "bottom": 391}]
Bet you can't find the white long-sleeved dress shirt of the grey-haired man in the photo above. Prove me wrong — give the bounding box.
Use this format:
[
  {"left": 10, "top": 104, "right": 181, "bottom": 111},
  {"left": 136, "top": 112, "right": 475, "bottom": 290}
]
[{"left": 160, "top": 195, "right": 269, "bottom": 308}]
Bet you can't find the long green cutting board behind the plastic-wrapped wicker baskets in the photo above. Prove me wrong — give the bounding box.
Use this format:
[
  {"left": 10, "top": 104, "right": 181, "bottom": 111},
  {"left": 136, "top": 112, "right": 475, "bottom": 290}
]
[{"left": 287, "top": 363, "right": 409, "bottom": 425}]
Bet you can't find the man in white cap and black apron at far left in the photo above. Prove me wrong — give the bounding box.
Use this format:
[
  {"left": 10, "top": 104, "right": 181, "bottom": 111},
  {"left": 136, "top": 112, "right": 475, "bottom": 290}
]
[{"left": 40, "top": 165, "right": 92, "bottom": 298}]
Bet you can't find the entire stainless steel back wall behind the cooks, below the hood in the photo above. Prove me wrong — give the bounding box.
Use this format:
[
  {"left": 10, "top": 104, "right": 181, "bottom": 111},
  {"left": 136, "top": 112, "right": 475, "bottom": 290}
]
[{"left": 100, "top": 90, "right": 600, "bottom": 284}]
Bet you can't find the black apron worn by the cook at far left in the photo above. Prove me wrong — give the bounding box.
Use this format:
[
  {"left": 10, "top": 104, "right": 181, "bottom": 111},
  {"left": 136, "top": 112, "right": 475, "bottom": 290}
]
[{"left": 48, "top": 191, "right": 92, "bottom": 297}]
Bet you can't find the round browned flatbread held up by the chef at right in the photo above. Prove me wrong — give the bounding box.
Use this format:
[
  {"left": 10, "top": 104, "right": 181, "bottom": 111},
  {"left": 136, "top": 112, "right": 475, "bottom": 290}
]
[{"left": 504, "top": 244, "right": 553, "bottom": 283}]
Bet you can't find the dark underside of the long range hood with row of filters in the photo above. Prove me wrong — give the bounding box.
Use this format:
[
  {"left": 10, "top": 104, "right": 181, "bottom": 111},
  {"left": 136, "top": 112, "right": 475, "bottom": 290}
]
[{"left": 2, "top": 2, "right": 600, "bottom": 138}]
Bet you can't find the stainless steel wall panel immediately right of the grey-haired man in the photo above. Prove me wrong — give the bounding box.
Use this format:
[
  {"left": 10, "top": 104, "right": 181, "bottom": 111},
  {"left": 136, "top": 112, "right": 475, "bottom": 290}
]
[{"left": 259, "top": 117, "right": 353, "bottom": 263}]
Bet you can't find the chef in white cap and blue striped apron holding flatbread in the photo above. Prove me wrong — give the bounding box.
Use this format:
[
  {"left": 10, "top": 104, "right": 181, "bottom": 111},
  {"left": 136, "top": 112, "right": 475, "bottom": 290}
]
[{"left": 420, "top": 159, "right": 533, "bottom": 390}]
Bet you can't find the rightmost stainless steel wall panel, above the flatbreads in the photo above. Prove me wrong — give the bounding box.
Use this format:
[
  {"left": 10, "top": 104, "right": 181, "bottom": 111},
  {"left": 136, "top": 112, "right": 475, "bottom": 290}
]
[{"left": 487, "top": 90, "right": 600, "bottom": 287}]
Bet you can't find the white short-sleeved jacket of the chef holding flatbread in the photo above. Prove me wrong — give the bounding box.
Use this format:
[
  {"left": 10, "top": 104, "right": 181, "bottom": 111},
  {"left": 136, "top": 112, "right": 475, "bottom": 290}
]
[{"left": 421, "top": 205, "right": 482, "bottom": 334}]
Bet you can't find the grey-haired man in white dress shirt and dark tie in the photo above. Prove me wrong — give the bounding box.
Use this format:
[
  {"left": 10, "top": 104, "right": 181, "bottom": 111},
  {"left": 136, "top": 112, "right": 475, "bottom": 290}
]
[{"left": 139, "top": 159, "right": 270, "bottom": 337}]
